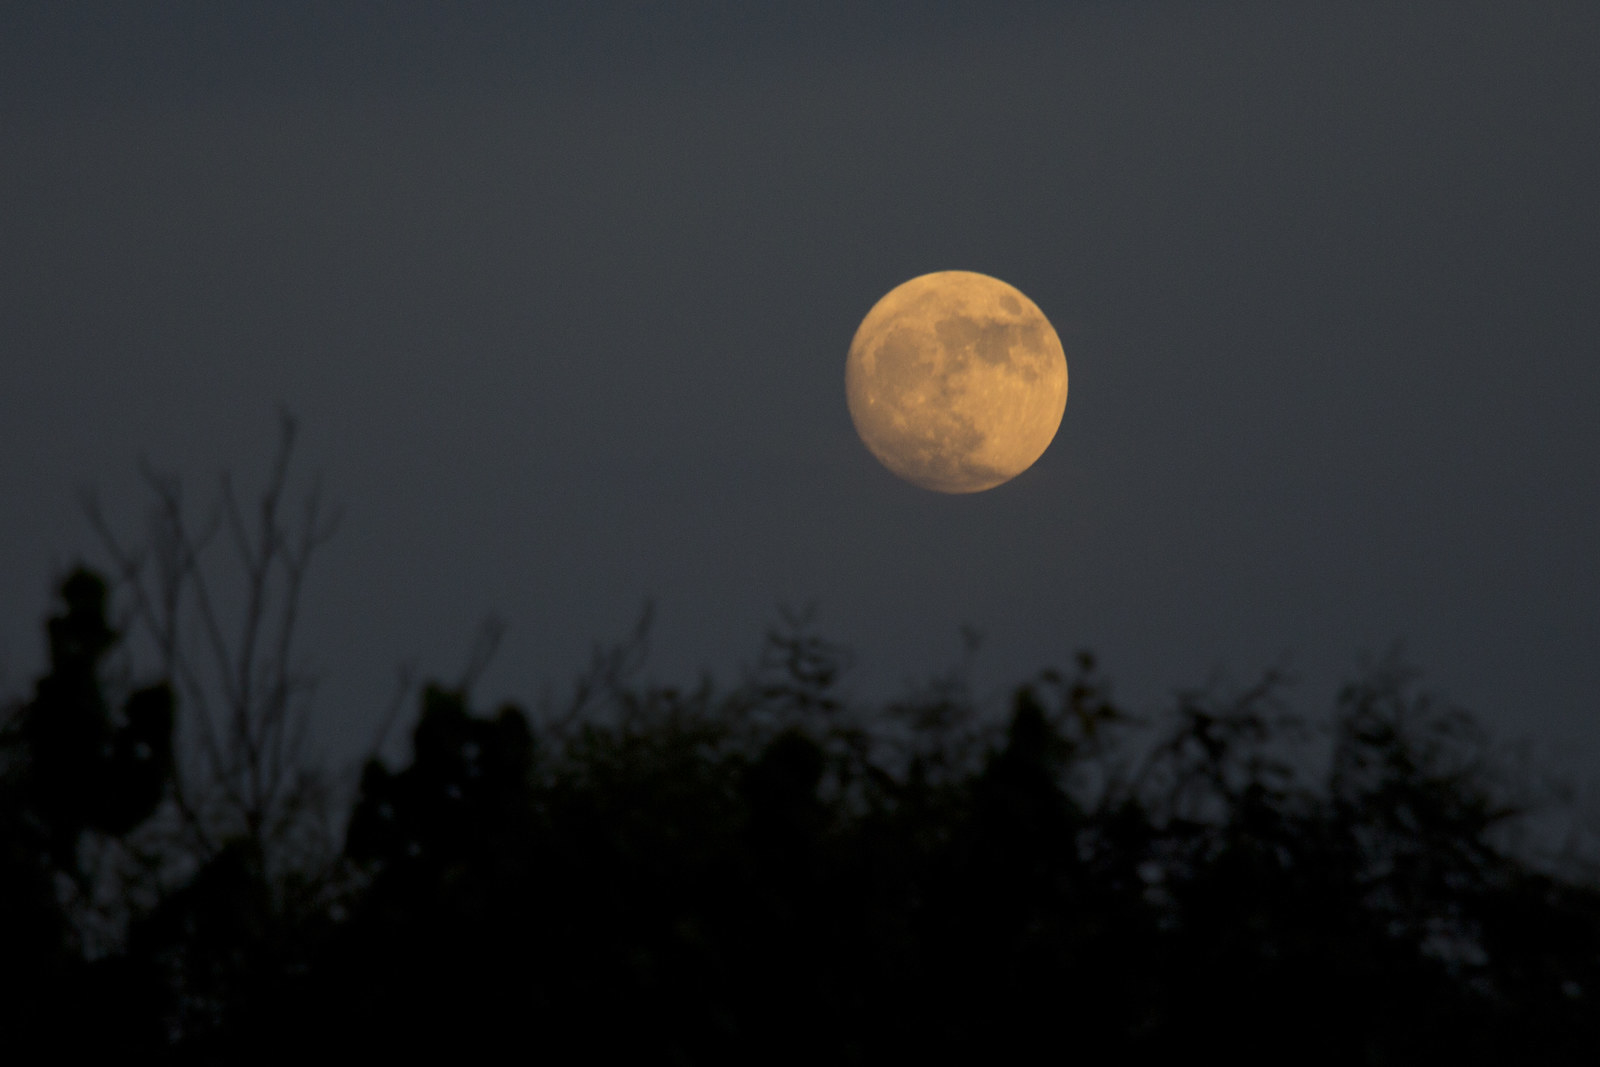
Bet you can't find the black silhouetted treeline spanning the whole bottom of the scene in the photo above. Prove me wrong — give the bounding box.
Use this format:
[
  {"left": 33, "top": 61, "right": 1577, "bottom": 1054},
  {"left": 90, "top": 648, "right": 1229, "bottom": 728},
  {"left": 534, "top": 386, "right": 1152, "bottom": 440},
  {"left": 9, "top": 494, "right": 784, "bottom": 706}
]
[{"left": 0, "top": 571, "right": 1600, "bottom": 1065}]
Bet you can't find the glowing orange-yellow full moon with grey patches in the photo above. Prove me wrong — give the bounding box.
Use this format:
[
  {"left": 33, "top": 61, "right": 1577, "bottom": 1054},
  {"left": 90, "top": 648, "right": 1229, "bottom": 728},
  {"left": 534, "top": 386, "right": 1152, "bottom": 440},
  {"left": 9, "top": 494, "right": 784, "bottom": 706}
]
[{"left": 845, "top": 270, "right": 1067, "bottom": 493}]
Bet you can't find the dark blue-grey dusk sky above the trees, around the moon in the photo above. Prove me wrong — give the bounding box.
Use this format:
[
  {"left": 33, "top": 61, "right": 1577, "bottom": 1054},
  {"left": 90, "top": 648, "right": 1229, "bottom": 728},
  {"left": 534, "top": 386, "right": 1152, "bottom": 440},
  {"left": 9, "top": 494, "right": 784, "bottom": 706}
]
[{"left": 0, "top": 0, "right": 1600, "bottom": 809}]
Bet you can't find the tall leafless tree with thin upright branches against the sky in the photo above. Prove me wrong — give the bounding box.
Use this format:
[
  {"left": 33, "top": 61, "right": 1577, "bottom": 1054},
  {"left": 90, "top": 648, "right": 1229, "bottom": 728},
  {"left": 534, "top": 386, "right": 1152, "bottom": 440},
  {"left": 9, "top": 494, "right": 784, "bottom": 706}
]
[{"left": 85, "top": 413, "right": 338, "bottom": 873}]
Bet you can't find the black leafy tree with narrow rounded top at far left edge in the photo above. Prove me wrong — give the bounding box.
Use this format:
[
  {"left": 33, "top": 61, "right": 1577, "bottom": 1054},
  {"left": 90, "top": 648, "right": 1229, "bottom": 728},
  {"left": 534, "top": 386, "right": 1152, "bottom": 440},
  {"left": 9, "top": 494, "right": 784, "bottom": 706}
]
[{"left": 0, "top": 569, "right": 173, "bottom": 1053}]
